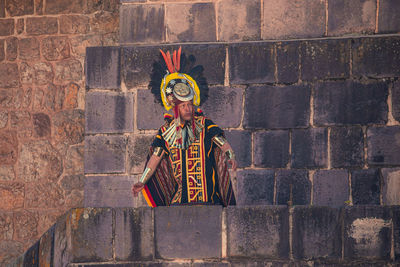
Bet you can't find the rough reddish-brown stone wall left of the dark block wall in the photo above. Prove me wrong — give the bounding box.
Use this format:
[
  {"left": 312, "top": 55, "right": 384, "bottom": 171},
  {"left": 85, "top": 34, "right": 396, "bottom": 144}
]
[{"left": 0, "top": 0, "right": 119, "bottom": 266}]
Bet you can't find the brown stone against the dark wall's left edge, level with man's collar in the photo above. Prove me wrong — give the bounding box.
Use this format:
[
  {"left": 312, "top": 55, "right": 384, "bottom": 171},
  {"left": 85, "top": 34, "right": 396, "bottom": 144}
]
[{"left": 52, "top": 109, "right": 85, "bottom": 145}]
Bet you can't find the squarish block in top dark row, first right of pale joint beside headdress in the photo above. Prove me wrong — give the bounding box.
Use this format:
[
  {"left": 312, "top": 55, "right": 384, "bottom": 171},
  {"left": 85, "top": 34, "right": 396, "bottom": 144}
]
[{"left": 229, "top": 42, "right": 275, "bottom": 84}]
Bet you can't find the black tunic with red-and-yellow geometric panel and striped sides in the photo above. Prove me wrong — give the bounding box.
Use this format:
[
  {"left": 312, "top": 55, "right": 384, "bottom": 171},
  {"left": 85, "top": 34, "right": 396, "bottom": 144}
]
[{"left": 143, "top": 116, "right": 236, "bottom": 207}]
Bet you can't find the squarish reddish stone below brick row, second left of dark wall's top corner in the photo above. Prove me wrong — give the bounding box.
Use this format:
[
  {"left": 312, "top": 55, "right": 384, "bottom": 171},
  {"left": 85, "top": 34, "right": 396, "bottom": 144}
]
[{"left": 41, "top": 36, "right": 70, "bottom": 61}]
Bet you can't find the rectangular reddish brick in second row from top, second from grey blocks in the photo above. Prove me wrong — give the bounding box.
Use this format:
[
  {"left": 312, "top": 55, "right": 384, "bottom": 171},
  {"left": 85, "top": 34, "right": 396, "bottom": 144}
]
[{"left": 60, "top": 15, "right": 90, "bottom": 34}]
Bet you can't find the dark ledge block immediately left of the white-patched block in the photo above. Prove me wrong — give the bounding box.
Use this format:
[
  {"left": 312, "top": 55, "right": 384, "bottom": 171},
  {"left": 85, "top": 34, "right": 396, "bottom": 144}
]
[{"left": 292, "top": 207, "right": 343, "bottom": 259}]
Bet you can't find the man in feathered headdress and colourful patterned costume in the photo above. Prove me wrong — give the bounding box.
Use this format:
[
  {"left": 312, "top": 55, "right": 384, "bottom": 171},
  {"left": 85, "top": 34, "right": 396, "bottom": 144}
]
[{"left": 132, "top": 48, "right": 237, "bottom": 207}]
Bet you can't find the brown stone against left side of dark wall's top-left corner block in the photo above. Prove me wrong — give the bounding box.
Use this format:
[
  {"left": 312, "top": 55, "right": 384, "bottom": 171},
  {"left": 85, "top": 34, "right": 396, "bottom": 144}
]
[{"left": 54, "top": 59, "right": 83, "bottom": 82}]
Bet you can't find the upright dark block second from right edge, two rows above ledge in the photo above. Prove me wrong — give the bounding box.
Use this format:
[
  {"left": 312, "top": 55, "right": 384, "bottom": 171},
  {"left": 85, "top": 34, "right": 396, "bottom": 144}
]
[{"left": 330, "top": 126, "right": 364, "bottom": 168}]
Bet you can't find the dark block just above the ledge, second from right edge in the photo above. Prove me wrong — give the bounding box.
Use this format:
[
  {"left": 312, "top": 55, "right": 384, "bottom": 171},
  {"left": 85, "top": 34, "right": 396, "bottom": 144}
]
[{"left": 351, "top": 169, "right": 381, "bottom": 205}]
